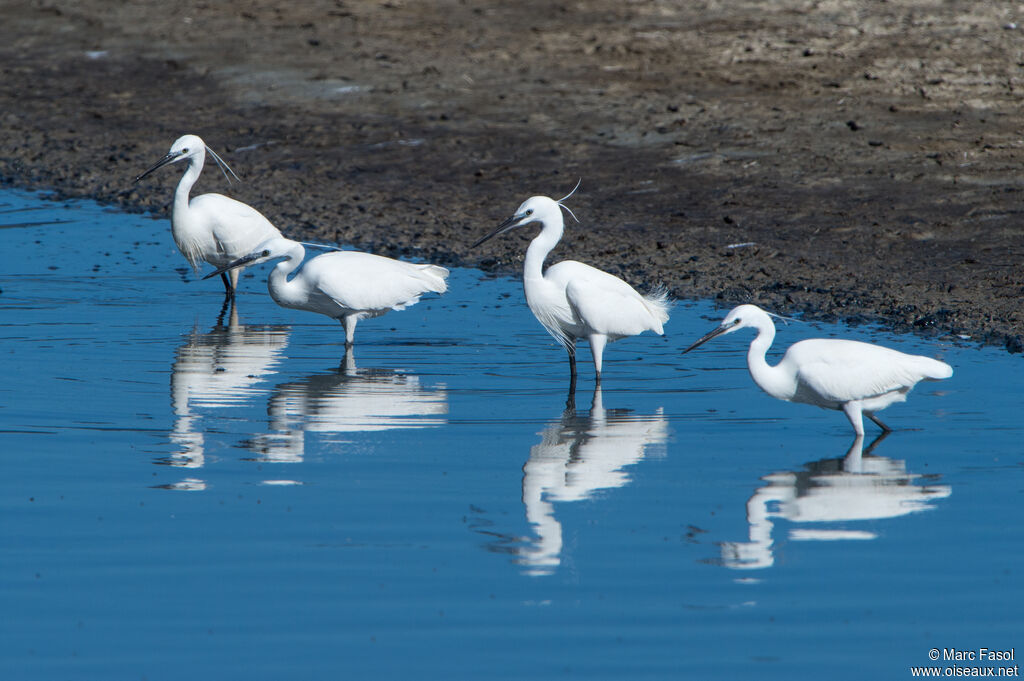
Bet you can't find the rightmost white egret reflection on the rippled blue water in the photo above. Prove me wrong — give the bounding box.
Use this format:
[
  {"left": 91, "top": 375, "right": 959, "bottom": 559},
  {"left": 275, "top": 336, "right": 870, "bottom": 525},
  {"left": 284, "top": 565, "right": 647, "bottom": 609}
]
[{"left": 721, "top": 433, "right": 952, "bottom": 569}]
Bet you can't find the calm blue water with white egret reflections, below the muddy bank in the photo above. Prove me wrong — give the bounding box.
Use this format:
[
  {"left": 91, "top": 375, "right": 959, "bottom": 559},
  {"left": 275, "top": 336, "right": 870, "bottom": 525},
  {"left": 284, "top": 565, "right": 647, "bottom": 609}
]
[{"left": 0, "top": 190, "right": 1024, "bottom": 680}]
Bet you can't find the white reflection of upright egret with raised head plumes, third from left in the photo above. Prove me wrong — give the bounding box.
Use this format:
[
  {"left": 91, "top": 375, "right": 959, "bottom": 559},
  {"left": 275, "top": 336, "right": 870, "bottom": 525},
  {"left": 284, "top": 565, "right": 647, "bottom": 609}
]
[{"left": 517, "top": 387, "right": 669, "bottom": 576}]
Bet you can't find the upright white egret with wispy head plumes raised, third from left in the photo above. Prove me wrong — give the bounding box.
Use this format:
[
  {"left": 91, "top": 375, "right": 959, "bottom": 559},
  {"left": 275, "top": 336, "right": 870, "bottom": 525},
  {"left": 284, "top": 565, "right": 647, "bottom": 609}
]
[{"left": 473, "top": 183, "right": 671, "bottom": 391}]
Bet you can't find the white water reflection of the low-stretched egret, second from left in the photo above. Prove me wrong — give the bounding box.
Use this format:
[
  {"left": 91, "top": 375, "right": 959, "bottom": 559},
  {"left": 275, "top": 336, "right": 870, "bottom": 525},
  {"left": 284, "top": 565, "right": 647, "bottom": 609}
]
[{"left": 245, "top": 347, "right": 447, "bottom": 463}]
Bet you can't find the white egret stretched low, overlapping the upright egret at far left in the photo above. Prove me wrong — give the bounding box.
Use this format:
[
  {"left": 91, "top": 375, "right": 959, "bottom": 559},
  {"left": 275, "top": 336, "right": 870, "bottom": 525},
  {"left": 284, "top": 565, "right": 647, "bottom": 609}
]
[{"left": 203, "top": 237, "right": 449, "bottom": 347}]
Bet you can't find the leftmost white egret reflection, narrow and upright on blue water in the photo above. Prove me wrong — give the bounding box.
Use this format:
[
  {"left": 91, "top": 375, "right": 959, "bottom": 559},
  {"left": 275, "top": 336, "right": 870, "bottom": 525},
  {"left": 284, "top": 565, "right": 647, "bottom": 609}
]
[{"left": 166, "top": 300, "right": 289, "bottom": 473}]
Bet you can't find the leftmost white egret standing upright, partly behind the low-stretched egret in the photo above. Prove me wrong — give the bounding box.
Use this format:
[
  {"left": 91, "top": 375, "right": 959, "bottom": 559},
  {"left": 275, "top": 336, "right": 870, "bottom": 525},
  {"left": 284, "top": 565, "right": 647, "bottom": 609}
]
[{"left": 135, "top": 135, "right": 281, "bottom": 296}]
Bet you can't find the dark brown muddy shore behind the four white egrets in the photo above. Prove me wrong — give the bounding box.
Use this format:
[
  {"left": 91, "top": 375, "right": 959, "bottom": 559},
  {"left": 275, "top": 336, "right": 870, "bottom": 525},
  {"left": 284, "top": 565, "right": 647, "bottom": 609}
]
[{"left": 0, "top": 0, "right": 1024, "bottom": 351}]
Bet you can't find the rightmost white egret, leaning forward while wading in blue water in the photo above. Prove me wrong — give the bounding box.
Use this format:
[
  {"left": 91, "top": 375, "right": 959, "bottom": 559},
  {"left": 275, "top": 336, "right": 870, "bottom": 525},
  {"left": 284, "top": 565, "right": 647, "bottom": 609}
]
[{"left": 683, "top": 305, "right": 953, "bottom": 436}]
